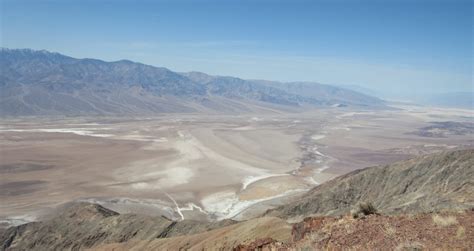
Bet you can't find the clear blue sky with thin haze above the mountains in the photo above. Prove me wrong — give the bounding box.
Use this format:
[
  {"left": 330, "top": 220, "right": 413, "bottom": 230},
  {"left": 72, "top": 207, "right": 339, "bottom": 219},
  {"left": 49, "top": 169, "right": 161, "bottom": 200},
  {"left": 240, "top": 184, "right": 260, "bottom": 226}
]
[{"left": 0, "top": 0, "right": 474, "bottom": 100}]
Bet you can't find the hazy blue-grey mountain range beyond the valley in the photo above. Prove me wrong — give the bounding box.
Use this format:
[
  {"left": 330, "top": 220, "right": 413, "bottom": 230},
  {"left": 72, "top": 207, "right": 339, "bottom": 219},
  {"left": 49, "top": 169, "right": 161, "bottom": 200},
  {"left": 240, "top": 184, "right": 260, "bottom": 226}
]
[{"left": 0, "top": 48, "right": 385, "bottom": 116}]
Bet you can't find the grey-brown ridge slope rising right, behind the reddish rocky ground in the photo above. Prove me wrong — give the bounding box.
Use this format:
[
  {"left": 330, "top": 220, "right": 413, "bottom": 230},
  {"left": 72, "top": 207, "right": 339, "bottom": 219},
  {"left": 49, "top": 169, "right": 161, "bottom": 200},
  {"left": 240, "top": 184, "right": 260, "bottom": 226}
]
[{"left": 266, "top": 149, "right": 474, "bottom": 218}]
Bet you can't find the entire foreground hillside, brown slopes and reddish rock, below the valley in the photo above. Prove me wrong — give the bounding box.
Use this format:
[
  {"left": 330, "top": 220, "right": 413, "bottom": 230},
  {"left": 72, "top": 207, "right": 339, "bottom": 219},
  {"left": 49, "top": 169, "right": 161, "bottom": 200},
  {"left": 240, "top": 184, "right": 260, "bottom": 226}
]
[{"left": 0, "top": 150, "right": 474, "bottom": 250}]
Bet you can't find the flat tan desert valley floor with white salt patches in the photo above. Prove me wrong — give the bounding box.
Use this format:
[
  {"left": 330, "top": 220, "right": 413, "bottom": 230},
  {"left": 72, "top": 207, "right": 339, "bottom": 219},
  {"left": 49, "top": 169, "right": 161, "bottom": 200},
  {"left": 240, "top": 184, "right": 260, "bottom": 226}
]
[{"left": 0, "top": 106, "right": 474, "bottom": 225}]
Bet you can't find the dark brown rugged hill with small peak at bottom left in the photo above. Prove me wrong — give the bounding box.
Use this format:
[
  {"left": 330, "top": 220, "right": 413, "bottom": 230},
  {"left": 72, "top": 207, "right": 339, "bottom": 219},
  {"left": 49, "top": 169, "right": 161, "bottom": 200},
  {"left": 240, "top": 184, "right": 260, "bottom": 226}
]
[{"left": 0, "top": 203, "right": 234, "bottom": 250}]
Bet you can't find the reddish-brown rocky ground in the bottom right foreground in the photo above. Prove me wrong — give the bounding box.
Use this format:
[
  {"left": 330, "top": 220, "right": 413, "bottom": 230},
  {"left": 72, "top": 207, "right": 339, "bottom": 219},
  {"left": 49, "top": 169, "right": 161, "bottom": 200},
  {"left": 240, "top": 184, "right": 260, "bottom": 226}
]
[{"left": 234, "top": 211, "right": 474, "bottom": 251}]
